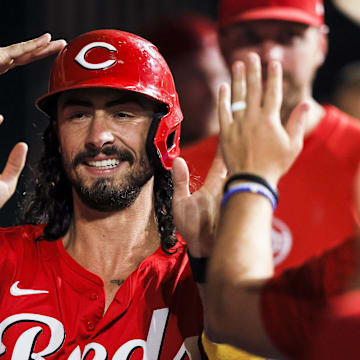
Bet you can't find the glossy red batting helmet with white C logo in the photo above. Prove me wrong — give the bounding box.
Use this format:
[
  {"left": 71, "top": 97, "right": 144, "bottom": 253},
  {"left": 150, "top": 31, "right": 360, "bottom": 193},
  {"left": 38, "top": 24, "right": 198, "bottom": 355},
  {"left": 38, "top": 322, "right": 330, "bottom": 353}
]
[{"left": 36, "top": 30, "right": 183, "bottom": 170}]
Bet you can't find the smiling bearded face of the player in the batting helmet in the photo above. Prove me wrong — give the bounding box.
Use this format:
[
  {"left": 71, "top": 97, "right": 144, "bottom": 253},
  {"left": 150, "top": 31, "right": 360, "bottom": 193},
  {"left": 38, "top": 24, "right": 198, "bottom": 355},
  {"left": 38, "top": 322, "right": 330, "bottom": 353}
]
[{"left": 57, "top": 88, "right": 156, "bottom": 211}]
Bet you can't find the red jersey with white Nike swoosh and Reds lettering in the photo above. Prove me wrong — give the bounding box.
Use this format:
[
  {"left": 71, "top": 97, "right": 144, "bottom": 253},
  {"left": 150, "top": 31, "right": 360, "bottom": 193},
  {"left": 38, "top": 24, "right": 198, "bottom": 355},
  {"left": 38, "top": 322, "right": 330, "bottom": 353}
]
[{"left": 0, "top": 226, "right": 203, "bottom": 360}]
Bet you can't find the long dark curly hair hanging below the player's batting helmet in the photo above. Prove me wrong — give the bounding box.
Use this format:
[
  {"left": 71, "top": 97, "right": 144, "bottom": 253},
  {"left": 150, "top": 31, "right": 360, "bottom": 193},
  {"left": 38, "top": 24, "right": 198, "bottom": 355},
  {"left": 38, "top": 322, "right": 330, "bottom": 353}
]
[{"left": 19, "top": 111, "right": 177, "bottom": 254}]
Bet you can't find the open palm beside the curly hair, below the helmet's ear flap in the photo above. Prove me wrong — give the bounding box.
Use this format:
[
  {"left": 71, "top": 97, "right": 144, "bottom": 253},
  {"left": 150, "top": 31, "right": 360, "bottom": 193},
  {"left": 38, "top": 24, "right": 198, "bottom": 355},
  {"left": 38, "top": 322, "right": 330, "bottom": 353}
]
[{"left": 173, "top": 148, "right": 227, "bottom": 257}]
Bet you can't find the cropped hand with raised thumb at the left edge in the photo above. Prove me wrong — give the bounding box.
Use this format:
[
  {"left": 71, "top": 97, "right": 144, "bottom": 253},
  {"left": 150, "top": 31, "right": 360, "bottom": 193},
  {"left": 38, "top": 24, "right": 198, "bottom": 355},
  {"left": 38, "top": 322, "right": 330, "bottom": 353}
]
[{"left": 0, "top": 115, "right": 28, "bottom": 208}]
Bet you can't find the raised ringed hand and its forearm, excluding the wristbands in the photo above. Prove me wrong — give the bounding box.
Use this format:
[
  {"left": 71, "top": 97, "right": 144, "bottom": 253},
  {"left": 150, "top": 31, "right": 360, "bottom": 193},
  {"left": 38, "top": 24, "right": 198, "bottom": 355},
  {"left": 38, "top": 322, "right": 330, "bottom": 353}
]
[{"left": 204, "top": 53, "right": 309, "bottom": 358}]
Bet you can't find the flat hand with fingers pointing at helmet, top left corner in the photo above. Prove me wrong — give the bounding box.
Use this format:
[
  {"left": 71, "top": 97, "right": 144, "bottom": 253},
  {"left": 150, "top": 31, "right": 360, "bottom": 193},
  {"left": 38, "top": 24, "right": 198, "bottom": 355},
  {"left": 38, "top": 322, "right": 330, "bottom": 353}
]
[{"left": 0, "top": 34, "right": 66, "bottom": 74}]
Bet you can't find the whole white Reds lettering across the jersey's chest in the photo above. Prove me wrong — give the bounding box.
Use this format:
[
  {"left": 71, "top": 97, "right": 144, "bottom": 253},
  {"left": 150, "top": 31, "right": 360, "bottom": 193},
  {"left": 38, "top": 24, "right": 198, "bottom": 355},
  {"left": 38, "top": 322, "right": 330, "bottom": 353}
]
[{"left": 0, "top": 308, "right": 201, "bottom": 360}]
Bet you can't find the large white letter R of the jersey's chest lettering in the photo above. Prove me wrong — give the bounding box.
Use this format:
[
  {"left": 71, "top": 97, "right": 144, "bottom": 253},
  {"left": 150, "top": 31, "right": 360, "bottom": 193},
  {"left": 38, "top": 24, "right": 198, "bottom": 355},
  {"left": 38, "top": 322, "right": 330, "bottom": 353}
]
[{"left": 0, "top": 314, "right": 65, "bottom": 360}]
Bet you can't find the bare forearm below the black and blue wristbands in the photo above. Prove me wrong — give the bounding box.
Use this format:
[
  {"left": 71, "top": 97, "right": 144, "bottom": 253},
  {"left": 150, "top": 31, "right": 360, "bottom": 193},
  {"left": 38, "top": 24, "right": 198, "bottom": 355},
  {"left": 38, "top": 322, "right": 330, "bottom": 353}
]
[{"left": 206, "top": 193, "right": 279, "bottom": 355}]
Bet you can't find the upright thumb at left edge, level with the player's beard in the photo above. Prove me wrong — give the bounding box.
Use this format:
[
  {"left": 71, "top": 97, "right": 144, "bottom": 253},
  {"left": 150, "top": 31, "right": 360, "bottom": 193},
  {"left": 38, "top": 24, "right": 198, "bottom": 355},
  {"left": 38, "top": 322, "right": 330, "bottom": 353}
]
[{"left": 1, "top": 142, "right": 28, "bottom": 185}]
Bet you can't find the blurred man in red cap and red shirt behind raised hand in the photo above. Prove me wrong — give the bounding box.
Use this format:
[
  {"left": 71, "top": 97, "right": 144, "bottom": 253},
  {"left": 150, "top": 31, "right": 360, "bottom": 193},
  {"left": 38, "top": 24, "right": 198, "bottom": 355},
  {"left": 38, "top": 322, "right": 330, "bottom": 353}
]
[{"left": 182, "top": 0, "right": 360, "bottom": 273}]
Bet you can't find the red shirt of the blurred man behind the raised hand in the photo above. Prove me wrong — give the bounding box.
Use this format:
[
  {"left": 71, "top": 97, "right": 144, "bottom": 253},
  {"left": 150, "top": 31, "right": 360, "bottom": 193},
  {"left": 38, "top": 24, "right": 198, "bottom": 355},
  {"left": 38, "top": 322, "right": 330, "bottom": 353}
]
[{"left": 182, "top": 106, "right": 360, "bottom": 273}]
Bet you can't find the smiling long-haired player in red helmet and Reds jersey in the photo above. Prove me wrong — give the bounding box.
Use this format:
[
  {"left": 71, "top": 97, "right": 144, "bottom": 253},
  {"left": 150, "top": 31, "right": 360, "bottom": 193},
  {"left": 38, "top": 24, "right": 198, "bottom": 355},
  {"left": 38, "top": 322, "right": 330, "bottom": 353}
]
[{"left": 0, "top": 30, "right": 224, "bottom": 360}]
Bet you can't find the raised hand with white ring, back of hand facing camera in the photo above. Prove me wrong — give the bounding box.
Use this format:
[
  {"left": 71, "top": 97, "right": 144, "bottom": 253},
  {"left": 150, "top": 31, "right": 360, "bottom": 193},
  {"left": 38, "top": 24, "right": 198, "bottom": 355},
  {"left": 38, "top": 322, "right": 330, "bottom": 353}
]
[{"left": 218, "top": 53, "right": 310, "bottom": 186}]
